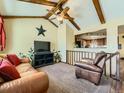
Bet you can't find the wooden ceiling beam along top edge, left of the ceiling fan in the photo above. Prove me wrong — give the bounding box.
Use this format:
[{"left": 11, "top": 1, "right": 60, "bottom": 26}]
[{"left": 18, "top": 0, "right": 57, "bottom": 7}]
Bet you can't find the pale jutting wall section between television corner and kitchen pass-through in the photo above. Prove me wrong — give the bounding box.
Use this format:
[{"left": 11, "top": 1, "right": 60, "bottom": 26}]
[{"left": 58, "top": 24, "right": 74, "bottom": 62}]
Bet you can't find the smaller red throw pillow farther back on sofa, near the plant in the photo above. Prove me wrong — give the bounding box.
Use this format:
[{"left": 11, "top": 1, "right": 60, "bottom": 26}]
[{"left": 7, "top": 54, "right": 20, "bottom": 66}]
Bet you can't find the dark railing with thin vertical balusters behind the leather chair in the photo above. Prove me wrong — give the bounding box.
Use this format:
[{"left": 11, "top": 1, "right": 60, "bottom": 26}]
[{"left": 66, "top": 50, "right": 120, "bottom": 80}]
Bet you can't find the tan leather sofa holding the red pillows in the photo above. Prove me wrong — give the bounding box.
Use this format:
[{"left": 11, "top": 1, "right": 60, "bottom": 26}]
[{"left": 0, "top": 63, "right": 49, "bottom": 93}]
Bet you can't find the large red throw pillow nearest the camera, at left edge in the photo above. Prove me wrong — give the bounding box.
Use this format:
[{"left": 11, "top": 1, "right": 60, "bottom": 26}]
[{"left": 0, "top": 59, "right": 20, "bottom": 81}]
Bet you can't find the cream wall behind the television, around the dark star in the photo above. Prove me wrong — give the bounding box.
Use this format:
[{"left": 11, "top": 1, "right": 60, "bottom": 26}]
[{"left": 2, "top": 19, "right": 57, "bottom": 54}]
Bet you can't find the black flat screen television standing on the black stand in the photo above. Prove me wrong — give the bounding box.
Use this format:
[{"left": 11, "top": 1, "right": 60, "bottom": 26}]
[{"left": 34, "top": 41, "right": 50, "bottom": 52}]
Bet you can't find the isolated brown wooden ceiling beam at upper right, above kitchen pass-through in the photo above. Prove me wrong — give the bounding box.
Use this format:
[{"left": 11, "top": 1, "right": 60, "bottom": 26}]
[{"left": 93, "top": 0, "right": 105, "bottom": 24}]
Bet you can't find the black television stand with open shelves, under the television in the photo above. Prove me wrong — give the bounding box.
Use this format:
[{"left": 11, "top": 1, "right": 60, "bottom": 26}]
[{"left": 33, "top": 52, "right": 54, "bottom": 68}]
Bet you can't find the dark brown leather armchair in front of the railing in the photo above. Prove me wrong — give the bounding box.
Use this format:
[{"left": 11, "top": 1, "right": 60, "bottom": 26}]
[{"left": 75, "top": 53, "right": 107, "bottom": 85}]
